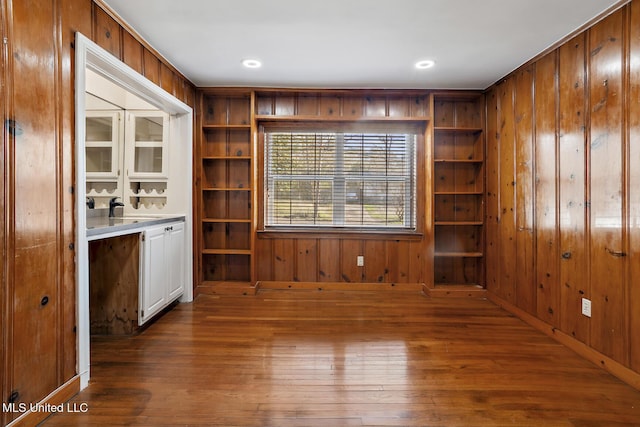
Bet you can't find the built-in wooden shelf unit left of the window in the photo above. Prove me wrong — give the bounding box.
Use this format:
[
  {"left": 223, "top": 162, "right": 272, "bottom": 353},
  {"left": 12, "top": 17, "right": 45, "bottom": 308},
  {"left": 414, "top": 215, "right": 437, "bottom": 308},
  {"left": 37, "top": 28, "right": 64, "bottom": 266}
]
[{"left": 196, "top": 89, "right": 254, "bottom": 284}]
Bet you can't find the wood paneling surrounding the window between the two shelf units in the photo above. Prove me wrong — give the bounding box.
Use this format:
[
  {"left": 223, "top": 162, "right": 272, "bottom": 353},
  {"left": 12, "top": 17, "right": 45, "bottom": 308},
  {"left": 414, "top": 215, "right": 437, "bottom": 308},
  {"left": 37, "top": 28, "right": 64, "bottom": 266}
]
[{"left": 255, "top": 91, "right": 433, "bottom": 286}]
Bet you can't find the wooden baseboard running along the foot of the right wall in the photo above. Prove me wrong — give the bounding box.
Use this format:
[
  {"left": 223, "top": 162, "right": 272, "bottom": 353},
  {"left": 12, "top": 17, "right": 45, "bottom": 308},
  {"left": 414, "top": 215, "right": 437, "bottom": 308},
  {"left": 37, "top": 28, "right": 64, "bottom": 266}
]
[{"left": 487, "top": 292, "right": 640, "bottom": 390}]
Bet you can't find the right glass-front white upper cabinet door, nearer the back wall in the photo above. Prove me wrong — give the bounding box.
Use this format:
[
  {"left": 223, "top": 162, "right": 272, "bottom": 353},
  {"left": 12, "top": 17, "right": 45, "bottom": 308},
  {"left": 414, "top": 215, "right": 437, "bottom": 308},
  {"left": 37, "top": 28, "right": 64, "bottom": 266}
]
[{"left": 125, "top": 111, "right": 169, "bottom": 179}]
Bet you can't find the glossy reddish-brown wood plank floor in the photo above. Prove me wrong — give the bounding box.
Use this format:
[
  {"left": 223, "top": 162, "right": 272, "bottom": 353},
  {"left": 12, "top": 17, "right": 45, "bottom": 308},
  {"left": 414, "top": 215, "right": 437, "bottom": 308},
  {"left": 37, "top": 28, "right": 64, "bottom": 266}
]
[{"left": 43, "top": 290, "right": 640, "bottom": 427}]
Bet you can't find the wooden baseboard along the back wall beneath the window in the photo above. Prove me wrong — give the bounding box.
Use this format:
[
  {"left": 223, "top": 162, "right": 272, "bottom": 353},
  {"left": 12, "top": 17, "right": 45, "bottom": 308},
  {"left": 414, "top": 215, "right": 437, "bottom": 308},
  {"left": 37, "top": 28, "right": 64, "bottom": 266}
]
[{"left": 256, "top": 281, "right": 423, "bottom": 294}]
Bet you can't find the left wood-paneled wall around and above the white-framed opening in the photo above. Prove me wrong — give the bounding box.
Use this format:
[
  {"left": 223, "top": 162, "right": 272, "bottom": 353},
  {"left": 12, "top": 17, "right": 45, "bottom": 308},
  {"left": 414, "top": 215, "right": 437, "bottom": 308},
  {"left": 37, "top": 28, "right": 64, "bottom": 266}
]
[{"left": 0, "top": 0, "right": 195, "bottom": 425}]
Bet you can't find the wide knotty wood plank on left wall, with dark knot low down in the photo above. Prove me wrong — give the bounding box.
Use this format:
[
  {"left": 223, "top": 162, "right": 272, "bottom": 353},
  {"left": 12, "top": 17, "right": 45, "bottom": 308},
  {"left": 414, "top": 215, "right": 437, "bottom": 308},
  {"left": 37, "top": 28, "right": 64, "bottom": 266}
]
[{"left": 10, "top": 2, "right": 61, "bottom": 412}]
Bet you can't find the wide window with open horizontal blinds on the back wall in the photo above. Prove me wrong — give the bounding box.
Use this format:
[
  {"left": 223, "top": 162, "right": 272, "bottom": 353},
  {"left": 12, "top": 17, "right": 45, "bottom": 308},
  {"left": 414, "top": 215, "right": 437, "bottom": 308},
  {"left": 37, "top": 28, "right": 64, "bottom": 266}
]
[{"left": 264, "top": 125, "right": 417, "bottom": 231}]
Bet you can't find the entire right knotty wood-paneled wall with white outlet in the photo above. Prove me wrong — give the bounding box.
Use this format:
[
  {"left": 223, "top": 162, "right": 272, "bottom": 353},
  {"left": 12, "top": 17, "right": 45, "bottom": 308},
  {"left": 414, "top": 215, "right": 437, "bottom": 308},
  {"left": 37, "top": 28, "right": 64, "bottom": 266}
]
[{"left": 486, "top": 0, "right": 640, "bottom": 382}]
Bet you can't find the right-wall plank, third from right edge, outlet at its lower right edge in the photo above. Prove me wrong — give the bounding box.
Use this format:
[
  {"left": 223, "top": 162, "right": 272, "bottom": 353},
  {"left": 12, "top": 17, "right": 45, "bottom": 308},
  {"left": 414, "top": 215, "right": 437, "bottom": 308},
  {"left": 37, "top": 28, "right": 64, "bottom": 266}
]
[{"left": 559, "top": 34, "right": 590, "bottom": 342}]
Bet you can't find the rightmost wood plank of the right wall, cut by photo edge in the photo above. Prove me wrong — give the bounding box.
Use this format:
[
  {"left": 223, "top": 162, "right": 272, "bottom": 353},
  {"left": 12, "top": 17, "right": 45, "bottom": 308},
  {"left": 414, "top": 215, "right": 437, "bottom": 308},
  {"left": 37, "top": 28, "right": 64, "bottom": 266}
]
[{"left": 627, "top": 1, "right": 640, "bottom": 372}]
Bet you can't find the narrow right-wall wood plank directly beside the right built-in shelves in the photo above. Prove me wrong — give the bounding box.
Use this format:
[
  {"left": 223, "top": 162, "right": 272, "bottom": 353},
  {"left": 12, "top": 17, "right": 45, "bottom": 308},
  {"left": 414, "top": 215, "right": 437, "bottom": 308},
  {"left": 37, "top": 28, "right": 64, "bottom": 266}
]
[{"left": 485, "top": 87, "right": 500, "bottom": 295}]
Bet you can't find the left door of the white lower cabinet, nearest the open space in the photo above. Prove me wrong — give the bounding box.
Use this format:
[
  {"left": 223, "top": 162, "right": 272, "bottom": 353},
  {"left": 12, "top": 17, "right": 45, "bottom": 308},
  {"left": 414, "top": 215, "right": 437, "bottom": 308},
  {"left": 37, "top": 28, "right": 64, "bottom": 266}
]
[{"left": 140, "top": 225, "right": 167, "bottom": 324}]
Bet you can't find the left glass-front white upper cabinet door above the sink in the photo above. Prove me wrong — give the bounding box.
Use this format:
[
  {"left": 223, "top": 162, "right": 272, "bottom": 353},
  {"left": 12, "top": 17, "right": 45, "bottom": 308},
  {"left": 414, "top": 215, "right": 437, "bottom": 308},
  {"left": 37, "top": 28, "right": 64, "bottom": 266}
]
[{"left": 85, "top": 111, "right": 123, "bottom": 181}]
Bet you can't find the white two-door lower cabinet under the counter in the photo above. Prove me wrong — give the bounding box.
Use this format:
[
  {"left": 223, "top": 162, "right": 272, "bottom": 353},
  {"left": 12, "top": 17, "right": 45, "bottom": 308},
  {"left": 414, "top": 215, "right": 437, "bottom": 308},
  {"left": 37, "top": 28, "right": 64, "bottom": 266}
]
[{"left": 138, "top": 222, "right": 185, "bottom": 325}]
